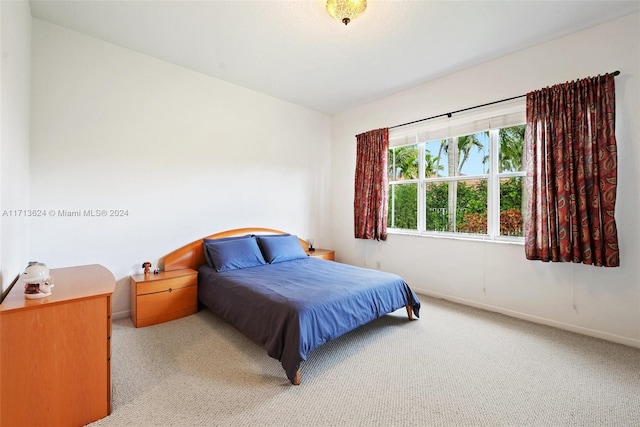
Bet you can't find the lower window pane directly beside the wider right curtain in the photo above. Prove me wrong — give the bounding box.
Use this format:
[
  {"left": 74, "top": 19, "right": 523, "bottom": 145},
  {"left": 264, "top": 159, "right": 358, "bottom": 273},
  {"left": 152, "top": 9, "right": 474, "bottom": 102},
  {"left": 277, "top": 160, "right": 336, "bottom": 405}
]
[{"left": 500, "top": 176, "right": 527, "bottom": 237}]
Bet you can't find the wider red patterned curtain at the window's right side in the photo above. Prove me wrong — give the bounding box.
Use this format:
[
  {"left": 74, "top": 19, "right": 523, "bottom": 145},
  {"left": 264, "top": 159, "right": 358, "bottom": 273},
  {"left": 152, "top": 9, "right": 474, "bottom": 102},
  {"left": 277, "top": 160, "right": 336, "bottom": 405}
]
[{"left": 525, "top": 74, "right": 620, "bottom": 267}]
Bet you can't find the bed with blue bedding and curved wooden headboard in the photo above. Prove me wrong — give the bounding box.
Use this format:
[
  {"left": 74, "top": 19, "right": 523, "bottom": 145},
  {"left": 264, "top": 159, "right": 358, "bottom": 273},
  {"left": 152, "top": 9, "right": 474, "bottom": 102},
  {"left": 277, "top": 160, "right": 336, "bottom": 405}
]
[{"left": 164, "top": 228, "right": 420, "bottom": 385}]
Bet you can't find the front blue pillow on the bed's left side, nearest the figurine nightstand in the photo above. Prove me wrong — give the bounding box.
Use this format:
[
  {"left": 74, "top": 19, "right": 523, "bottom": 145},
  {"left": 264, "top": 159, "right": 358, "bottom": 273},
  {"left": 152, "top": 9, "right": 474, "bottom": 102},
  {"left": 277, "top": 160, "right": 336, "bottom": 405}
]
[{"left": 205, "top": 236, "right": 266, "bottom": 271}]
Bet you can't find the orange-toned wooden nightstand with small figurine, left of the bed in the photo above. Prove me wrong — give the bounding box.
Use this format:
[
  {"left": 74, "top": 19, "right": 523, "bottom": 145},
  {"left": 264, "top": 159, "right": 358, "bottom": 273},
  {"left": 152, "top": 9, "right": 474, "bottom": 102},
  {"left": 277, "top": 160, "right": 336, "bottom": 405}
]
[{"left": 131, "top": 268, "right": 198, "bottom": 328}]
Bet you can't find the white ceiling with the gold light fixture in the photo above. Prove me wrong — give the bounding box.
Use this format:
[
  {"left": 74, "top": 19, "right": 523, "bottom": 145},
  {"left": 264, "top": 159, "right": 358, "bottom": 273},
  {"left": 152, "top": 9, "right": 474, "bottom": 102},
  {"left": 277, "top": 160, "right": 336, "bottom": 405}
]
[{"left": 30, "top": 0, "right": 640, "bottom": 114}]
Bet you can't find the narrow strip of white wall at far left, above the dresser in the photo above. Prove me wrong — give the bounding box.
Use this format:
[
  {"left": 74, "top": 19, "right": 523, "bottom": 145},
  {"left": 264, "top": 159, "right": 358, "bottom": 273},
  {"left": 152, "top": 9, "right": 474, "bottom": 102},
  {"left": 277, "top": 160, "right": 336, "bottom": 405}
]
[{"left": 0, "top": 1, "right": 31, "bottom": 291}]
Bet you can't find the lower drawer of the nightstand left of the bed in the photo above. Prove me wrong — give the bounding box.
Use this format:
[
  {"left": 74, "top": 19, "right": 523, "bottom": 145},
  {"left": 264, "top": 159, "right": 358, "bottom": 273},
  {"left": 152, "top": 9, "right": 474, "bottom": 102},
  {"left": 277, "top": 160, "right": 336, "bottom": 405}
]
[{"left": 137, "top": 286, "right": 198, "bottom": 327}]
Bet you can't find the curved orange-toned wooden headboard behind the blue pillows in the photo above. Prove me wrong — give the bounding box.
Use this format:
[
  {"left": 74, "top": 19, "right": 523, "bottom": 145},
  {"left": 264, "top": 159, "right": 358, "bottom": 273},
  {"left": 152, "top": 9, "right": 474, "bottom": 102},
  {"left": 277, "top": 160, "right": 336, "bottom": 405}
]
[{"left": 163, "top": 227, "right": 309, "bottom": 271}]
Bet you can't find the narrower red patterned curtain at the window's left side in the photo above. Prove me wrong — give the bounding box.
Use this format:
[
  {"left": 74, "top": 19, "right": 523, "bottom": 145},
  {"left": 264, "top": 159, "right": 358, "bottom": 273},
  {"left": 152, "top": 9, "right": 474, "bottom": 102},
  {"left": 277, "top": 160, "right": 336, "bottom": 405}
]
[{"left": 353, "top": 128, "right": 389, "bottom": 240}]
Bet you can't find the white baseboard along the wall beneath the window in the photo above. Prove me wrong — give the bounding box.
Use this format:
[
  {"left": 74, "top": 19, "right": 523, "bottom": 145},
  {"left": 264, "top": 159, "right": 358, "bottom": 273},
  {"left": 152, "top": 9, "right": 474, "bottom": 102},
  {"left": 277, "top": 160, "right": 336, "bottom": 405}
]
[{"left": 420, "top": 290, "right": 640, "bottom": 348}]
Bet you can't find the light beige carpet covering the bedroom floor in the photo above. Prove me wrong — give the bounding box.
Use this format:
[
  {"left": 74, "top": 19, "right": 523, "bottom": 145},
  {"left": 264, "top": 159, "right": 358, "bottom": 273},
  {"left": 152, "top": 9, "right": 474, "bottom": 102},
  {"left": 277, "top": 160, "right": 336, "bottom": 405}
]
[{"left": 91, "top": 296, "right": 640, "bottom": 427}]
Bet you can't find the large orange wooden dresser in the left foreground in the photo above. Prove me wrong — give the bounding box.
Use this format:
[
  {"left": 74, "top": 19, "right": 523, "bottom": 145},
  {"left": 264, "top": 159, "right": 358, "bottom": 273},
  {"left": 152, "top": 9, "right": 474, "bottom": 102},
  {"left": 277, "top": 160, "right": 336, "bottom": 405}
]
[{"left": 0, "top": 265, "right": 115, "bottom": 427}]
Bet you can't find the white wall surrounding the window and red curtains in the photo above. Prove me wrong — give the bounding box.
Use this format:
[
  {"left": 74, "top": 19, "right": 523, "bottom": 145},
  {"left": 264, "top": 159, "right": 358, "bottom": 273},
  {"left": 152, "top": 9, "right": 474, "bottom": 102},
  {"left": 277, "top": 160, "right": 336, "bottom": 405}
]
[{"left": 331, "top": 14, "right": 640, "bottom": 347}]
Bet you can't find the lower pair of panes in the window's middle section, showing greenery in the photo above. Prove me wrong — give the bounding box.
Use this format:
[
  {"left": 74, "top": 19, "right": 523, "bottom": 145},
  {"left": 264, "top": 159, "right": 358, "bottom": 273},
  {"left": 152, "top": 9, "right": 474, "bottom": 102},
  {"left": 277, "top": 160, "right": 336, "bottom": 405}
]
[{"left": 425, "top": 179, "right": 487, "bottom": 234}]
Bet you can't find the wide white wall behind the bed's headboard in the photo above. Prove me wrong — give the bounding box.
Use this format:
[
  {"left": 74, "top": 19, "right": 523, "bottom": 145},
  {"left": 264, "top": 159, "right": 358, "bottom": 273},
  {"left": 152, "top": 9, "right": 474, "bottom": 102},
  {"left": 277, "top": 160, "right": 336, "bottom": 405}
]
[{"left": 31, "top": 19, "right": 331, "bottom": 315}]
